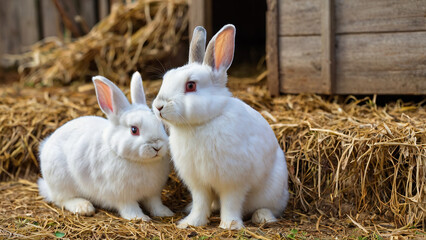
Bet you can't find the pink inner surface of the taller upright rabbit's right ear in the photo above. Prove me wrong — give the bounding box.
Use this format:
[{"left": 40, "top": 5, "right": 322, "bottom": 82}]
[{"left": 214, "top": 28, "right": 234, "bottom": 70}]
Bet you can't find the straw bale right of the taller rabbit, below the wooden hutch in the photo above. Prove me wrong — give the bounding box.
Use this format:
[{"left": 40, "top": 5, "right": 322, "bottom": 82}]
[{"left": 236, "top": 86, "right": 426, "bottom": 227}]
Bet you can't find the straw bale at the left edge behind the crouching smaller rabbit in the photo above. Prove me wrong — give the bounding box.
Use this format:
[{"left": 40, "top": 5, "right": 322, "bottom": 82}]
[{"left": 0, "top": 88, "right": 99, "bottom": 179}]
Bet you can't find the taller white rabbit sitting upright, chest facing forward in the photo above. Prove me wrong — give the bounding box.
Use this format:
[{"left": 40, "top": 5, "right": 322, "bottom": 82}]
[{"left": 153, "top": 25, "right": 289, "bottom": 229}]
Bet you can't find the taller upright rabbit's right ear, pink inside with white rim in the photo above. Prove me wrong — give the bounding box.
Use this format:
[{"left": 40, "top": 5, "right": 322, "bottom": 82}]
[{"left": 203, "top": 24, "right": 235, "bottom": 71}]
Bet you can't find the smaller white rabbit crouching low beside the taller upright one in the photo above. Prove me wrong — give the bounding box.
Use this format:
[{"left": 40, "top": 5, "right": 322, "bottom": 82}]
[{"left": 38, "top": 72, "right": 173, "bottom": 221}]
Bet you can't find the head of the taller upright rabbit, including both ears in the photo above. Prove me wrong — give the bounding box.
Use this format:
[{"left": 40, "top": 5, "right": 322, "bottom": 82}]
[{"left": 153, "top": 24, "right": 235, "bottom": 125}]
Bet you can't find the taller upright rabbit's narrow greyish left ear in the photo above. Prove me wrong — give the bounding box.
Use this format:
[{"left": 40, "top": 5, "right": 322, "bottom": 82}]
[{"left": 189, "top": 26, "right": 206, "bottom": 63}]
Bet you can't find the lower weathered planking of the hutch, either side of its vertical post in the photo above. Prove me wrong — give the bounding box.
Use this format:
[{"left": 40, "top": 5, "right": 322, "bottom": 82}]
[{"left": 279, "top": 32, "right": 426, "bottom": 94}]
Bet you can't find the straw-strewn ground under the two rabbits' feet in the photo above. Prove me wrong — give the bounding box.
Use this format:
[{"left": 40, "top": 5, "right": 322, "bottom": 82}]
[{"left": 0, "top": 179, "right": 374, "bottom": 239}]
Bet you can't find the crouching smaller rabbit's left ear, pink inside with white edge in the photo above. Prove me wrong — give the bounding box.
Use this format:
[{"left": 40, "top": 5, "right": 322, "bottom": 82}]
[{"left": 92, "top": 76, "right": 130, "bottom": 118}]
